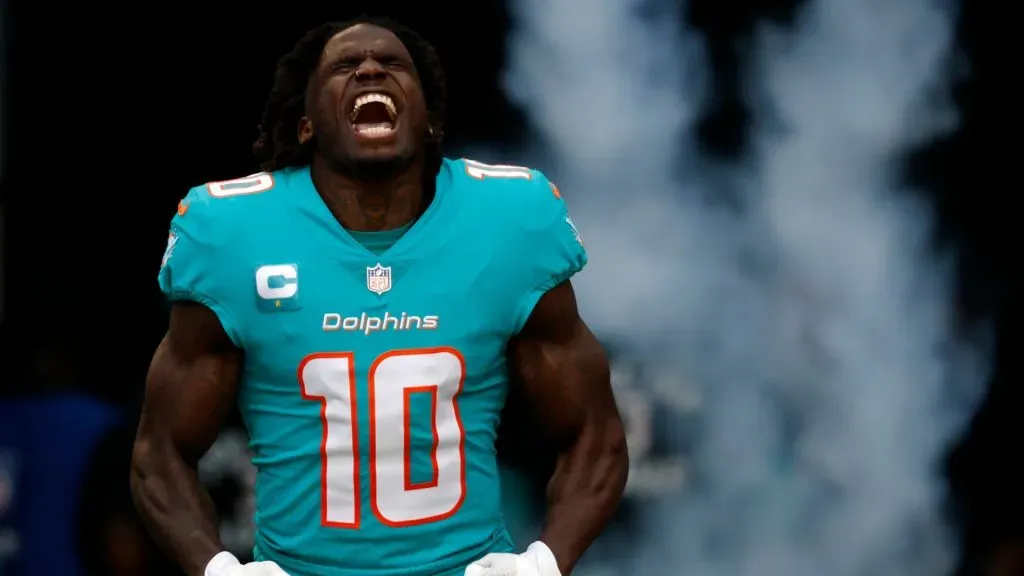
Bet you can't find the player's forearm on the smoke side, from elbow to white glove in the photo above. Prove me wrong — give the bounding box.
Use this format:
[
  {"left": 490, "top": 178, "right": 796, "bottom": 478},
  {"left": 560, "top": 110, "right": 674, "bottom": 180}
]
[{"left": 541, "top": 417, "right": 629, "bottom": 575}]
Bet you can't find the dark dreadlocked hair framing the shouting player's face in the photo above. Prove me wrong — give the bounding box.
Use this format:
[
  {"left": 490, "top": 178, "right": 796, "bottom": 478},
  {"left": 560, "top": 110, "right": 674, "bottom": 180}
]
[{"left": 253, "top": 15, "right": 447, "bottom": 178}]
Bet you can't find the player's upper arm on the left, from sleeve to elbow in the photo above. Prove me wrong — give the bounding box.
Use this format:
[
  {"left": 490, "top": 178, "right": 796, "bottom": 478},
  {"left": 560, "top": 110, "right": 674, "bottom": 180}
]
[{"left": 138, "top": 302, "right": 242, "bottom": 460}]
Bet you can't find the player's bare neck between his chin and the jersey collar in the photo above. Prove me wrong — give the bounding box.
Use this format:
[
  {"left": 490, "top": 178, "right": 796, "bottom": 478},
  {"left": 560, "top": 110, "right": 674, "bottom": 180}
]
[{"left": 310, "top": 155, "right": 425, "bottom": 232}]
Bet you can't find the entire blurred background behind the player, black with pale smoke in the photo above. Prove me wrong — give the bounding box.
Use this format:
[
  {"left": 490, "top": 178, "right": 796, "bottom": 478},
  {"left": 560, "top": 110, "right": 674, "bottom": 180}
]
[{"left": 0, "top": 0, "right": 1024, "bottom": 576}]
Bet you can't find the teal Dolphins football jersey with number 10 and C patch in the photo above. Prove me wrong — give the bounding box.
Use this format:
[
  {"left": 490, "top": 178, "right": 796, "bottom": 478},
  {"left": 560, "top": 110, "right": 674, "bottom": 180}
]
[{"left": 160, "top": 160, "right": 587, "bottom": 576}]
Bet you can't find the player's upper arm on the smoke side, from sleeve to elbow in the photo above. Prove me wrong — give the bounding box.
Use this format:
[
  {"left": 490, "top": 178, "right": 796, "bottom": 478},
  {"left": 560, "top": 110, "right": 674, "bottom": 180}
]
[{"left": 510, "top": 282, "right": 618, "bottom": 442}]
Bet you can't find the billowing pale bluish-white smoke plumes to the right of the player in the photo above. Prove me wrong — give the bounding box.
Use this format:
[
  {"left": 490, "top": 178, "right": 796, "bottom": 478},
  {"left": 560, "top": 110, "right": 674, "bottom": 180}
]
[{"left": 506, "top": 0, "right": 986, "bottom": 576}]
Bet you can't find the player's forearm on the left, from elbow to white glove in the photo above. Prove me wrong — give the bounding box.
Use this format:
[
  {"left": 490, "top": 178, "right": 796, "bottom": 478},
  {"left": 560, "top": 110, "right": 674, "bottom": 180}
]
[{"left": 131, "top": 440, "right": 223, "bottom": 576}]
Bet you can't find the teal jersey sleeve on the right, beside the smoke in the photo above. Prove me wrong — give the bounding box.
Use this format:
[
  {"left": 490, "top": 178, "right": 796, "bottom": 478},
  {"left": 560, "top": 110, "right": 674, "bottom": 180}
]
[{"left": 513, "top": 170, "right": 587, "bottom": 333}]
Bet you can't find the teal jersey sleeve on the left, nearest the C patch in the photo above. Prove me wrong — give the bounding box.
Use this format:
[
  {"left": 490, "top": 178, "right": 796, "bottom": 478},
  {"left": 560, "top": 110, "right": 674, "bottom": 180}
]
[{"left": 158, "top": 187, "right": 243, "bottom": 347}]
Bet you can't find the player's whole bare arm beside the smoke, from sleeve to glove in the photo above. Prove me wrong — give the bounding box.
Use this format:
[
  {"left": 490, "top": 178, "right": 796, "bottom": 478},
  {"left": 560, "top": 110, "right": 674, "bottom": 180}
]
[{"left": 509, "top": 282, "right": 629, "bottom": 575}]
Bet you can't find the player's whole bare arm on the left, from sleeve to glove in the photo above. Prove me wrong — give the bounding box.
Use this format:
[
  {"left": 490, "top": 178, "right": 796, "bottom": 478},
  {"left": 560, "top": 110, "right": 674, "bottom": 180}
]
[{"left": 131, "top": 302, "right": 242, "bottom": 576}]
